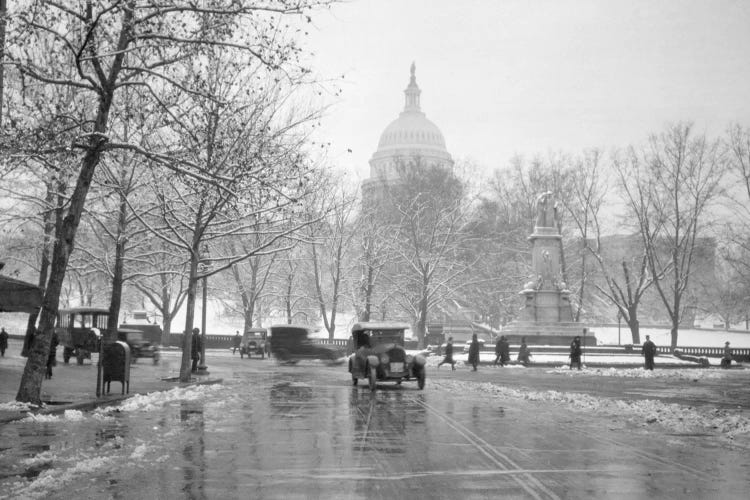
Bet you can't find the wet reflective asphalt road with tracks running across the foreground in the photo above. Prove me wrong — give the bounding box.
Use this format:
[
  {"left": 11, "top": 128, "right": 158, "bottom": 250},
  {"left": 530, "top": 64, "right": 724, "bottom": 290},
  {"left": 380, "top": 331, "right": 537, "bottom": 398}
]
[{"left": 0, "top": 353, "right": 750, "bottom": 499}]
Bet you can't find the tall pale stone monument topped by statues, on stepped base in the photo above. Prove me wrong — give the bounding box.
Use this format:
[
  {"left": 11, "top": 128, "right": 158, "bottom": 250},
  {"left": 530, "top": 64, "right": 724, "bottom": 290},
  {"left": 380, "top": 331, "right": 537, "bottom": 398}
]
[{"left": 503, "top": 191, "right": 596, "bottom": 345}]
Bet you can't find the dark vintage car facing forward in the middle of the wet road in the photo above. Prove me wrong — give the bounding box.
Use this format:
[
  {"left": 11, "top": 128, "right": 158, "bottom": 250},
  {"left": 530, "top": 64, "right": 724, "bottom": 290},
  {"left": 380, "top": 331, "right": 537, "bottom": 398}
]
[{"left": 349, "top": 322, "right": 427, "bottom": 391}]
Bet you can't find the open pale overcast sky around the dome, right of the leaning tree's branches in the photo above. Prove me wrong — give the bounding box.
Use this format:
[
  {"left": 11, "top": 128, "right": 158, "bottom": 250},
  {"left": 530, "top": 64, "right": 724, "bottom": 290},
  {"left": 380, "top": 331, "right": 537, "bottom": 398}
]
[{"left": 309, "top": 0, "right": 750, "bottom": 183}]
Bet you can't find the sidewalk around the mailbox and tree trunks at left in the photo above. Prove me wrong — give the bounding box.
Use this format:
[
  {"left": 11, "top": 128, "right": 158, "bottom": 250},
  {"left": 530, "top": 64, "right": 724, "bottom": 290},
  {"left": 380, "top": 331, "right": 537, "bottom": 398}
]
[{"left": 0, "top": 339, "right": 221, "bottom": 424}]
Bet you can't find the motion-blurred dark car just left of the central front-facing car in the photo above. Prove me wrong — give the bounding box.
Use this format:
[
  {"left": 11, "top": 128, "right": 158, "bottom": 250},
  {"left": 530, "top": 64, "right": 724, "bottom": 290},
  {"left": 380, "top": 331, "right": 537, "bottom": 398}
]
[{"left": 269, "top": 325, "right": 345, "bottom": 363}]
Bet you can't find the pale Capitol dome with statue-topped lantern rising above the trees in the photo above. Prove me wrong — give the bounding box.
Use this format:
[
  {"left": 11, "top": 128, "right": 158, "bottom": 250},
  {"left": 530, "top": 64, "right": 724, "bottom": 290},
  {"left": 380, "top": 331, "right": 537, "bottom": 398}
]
[{"left": 362, "top": 63, "right": 453, "bottom": 199}]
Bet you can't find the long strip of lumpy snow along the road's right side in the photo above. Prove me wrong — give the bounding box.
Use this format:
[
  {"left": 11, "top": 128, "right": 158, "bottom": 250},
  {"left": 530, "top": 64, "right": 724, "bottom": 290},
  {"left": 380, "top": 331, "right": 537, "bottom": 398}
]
[{"left": 430, "top": 380, "right": 750, "bottom": 440}]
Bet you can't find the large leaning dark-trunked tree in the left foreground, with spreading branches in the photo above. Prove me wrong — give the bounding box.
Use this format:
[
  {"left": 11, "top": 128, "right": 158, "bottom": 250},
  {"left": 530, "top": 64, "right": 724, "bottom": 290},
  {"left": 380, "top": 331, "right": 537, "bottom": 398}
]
[{"left": 5, "top": 0, "right": 332, "bottom": 404}]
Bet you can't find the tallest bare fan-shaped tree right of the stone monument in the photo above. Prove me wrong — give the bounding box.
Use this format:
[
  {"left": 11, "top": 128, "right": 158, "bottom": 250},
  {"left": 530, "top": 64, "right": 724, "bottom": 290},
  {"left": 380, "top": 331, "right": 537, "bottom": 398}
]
[{"left": 617, "top": 124, "right": 726, "bottom": 349}]
